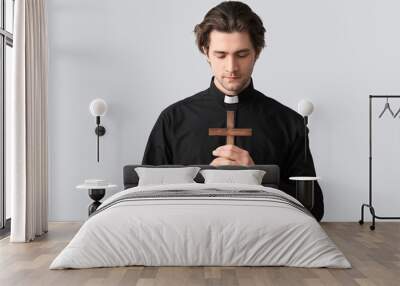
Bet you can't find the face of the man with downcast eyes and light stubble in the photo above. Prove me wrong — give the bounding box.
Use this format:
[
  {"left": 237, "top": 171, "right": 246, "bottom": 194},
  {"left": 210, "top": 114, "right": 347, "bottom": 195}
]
[{"left": 206, "top": 30, "right": 257, "bottom": 95}]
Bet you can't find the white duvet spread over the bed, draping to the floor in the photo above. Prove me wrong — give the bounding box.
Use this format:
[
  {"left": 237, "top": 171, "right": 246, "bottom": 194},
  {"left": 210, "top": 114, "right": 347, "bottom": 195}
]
[{"left": 50, "top": 183, "right": 351, "bottom": 269}]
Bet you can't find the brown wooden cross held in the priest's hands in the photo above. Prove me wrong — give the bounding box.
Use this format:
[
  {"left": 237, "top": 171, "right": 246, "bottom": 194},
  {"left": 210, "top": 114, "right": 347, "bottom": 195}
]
[{"left": 208, "top": 110, "right": 252, "bottom": 145}]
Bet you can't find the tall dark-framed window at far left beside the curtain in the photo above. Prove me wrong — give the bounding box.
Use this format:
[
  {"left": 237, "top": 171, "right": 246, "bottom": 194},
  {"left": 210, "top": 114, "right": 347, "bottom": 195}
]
[{"left": 0, "top": 0, "right": 14, "bottom": 233}]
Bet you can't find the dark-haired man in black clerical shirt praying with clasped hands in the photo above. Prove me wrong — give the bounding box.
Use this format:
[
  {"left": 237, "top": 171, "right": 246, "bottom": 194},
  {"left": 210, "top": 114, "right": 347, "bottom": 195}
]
[{"left": 142, "top": 1, "right": 324, "bottom": 220}]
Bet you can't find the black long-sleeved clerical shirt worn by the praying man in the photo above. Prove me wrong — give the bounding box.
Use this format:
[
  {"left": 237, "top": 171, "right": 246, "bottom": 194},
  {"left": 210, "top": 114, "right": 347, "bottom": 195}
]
[{"left": 142, "top": 79, "right": 324, "bottom": 220}]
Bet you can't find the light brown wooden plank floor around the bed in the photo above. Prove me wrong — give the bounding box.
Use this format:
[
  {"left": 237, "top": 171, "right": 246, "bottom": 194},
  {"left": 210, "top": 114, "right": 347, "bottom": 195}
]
[{"left": 0, "top": 222, "right": 400, "bottom": 286}]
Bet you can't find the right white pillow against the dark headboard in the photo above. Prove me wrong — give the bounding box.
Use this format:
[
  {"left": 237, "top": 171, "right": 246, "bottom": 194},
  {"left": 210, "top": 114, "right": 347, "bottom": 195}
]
[{"left": 200, "top": 170, "right": 265, "bottom": 185}]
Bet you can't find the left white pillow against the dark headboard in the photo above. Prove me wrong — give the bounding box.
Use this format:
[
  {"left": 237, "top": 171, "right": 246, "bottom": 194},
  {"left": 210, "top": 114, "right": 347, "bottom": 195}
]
[{"left": 135, "top": 167, "right": 200, "bottom": 186}]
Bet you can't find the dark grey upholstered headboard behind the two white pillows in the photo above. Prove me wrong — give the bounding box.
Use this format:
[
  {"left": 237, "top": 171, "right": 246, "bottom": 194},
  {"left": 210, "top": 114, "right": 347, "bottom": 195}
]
[{"left": 124, "top": 165, "right": 279, "bottom": 189}]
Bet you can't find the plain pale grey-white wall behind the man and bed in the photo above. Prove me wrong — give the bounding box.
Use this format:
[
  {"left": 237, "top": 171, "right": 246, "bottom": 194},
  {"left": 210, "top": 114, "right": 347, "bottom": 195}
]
[{"left": 48, "top": 0, "right": 400, "bottom": 221}]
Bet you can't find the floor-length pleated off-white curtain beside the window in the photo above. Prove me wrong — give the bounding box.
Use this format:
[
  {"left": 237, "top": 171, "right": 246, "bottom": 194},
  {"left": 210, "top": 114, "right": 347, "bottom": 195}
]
[{"left": 6, "top": 0, "right": 48, "bottom": 242}]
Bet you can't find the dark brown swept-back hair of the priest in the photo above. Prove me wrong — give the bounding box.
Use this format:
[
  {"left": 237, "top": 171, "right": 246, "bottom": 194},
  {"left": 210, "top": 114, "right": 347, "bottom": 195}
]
[{"left": 194, "top": 1, "right": 265, "bottom": 55}]
